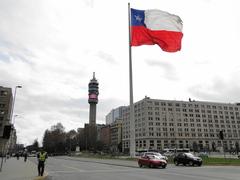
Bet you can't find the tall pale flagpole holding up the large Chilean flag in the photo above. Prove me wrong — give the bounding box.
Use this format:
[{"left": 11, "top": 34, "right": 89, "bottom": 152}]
[{"left": 128, "top": 3, "right": 135, "bottom": 157}]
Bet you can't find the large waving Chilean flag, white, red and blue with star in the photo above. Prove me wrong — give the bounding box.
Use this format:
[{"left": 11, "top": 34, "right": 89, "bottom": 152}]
[{"left": 131, "top": 8, "right": 183, "bottom": 52}]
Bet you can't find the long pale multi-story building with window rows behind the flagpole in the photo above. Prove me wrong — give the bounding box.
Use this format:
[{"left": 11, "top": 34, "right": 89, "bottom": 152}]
[{"left": 123, "top": 97, "right": 240, "bottom": 151}]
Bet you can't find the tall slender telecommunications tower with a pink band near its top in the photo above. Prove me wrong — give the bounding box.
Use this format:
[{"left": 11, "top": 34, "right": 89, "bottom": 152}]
[{"left": 88, "top": 72, "right": 99, "bottom": 125}]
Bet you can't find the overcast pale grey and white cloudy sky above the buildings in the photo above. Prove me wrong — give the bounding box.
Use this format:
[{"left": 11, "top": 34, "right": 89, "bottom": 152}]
[{"left": 0, "top": 0, "right": 240, "bottom": 145}]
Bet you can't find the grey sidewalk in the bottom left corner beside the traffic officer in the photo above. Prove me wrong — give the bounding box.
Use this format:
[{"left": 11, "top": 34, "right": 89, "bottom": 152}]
[{"left": 0, "top": 157, "right": 46, "bottom": 180}]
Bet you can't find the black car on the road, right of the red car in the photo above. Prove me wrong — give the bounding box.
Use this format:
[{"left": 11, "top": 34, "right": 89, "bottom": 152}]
[{"left": 173, "top": 153, "right": 202, "bottom": 166}]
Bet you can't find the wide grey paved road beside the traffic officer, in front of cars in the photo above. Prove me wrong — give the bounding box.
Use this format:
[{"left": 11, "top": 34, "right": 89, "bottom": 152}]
[{"left": 32, "top": 157, "right": 240, "bottom": 180}]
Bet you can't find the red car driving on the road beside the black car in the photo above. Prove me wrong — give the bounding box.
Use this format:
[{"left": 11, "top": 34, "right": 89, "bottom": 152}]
[{"left": 138, "top": 155, "right": 167, "bottom": 168}]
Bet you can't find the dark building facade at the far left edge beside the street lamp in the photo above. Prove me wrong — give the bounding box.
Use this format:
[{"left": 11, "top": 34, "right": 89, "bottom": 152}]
[{"left": 0, "top": 86, "right": 12, "bottom": 151}]
